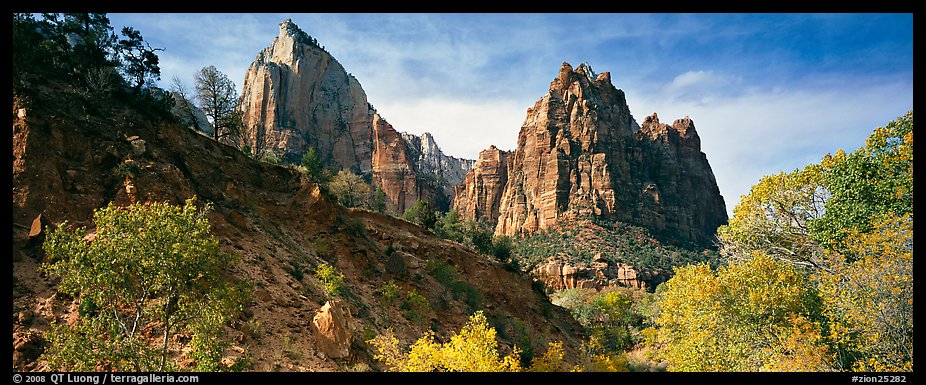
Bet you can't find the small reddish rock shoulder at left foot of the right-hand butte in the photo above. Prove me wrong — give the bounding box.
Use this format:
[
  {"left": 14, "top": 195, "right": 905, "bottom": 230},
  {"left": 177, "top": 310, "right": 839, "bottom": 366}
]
[{"left": 453, "top": 145, "right": 512, "bottom": 223}]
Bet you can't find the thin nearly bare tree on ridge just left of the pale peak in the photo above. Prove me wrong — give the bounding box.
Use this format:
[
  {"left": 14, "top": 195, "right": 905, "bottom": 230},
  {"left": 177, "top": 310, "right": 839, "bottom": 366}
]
[{"left": 196, "top": 66, "right": 241, "bottom": 141}]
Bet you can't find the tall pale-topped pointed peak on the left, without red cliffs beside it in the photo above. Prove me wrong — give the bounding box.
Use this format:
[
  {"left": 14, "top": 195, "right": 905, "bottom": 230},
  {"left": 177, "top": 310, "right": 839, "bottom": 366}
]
[{"left": 241, "top": 20, "right": 374, "bottom": 173}]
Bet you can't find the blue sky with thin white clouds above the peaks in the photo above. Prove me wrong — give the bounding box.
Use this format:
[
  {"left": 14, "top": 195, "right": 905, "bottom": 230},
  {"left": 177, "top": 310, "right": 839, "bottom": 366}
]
[{"left": 109, "top": 13, "right": 913, "bottom": 212}]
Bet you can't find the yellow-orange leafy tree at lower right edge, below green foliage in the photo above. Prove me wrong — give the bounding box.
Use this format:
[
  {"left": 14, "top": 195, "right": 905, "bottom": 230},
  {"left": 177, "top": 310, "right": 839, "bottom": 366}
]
[{"left": 815, "top": 214, "right": 913, "bottom": 371}]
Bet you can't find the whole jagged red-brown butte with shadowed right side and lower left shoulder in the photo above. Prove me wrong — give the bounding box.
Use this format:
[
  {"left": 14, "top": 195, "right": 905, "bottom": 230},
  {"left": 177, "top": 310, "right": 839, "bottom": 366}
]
[{"left": 454, "top": 63, "right": 727, "bottom": 247}]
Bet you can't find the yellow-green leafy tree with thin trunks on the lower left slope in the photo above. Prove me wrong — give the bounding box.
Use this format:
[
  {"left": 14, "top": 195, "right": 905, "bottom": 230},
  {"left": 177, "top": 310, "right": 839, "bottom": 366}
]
[{"left": 42, "top": 199, "right": 246, "bottom": 371}]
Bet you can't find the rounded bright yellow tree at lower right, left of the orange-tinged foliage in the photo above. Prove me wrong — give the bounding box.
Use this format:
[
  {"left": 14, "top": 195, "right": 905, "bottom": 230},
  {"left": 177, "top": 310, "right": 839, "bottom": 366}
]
[{"left": 646, "top": 253, "right": 820, "bottom": 371}]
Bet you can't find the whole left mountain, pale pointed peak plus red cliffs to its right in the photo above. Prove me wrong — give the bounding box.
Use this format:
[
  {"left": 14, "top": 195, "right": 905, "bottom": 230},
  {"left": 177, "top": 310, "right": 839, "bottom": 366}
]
[{"left": 241, "top": 20, "right": 472, "bottom": 214}]
